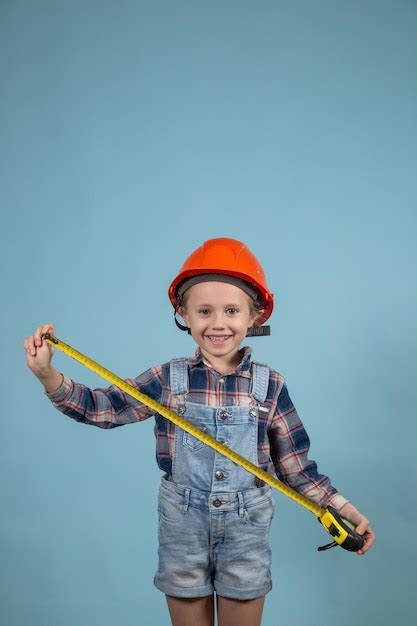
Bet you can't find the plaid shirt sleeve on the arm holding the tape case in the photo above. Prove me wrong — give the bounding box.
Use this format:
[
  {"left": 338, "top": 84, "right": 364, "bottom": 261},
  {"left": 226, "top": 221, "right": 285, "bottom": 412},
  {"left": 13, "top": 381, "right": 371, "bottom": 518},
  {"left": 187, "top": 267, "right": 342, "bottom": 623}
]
[{"left": 268, "top": 383, "right": 348, "bottom": 510}]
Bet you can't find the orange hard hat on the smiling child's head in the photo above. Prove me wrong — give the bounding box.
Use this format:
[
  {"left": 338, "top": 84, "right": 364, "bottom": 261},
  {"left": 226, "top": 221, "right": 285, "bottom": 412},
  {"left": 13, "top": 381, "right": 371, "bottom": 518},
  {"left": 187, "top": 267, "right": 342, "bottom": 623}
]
[{"left": 168, "top": 237, "right": 274, "bottom": 324}]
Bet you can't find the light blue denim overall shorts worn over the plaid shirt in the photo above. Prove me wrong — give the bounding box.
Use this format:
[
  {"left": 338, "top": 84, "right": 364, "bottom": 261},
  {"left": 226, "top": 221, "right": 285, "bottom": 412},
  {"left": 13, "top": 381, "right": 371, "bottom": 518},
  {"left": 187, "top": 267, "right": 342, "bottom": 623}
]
[{"left": 154, "top": 359, "right": 275, "bottom": 600}]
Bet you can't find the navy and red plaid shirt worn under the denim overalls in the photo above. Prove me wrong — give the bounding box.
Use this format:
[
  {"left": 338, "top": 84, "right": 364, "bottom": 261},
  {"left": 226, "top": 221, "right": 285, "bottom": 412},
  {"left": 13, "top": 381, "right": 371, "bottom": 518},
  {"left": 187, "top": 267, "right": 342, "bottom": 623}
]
[{"left": 44, "top": 347, "right": 347, "bottom": 509}]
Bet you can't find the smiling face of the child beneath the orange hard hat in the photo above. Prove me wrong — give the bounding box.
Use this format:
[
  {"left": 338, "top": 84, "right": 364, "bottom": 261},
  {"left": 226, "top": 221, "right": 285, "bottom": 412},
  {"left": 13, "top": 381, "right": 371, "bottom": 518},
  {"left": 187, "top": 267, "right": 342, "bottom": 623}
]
[{"left": 180, "top": 281, "right": 257, "bottom": 365}]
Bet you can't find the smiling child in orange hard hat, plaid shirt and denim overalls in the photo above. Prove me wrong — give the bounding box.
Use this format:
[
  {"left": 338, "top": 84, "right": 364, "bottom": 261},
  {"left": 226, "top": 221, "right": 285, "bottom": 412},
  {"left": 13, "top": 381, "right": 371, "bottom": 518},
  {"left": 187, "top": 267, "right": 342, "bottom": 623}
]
[{"left": 24, "top": 238, "right": 374, "bottom": 626}]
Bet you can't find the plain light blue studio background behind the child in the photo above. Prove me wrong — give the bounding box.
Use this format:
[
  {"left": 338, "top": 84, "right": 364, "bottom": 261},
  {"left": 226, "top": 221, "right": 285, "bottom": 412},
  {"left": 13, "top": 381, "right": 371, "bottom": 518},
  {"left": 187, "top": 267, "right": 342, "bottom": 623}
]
[{"left": 0, "top": 0, "right": 417, "bottom": 626}]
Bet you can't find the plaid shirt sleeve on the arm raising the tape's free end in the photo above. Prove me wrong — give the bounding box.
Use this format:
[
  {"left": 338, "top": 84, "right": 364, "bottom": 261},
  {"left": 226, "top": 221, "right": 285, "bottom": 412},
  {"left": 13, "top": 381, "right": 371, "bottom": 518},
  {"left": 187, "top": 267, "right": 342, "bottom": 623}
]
[{"left": 44, "top": 366, "right": 162, "bottom": 428}]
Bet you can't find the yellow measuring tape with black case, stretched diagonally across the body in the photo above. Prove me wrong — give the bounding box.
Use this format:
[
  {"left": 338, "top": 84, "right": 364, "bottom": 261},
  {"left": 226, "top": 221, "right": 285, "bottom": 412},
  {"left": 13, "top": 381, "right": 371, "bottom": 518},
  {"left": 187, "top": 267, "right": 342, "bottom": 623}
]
[{"left": 43, "top": 333, "right": 364, "bottom": 552}]
